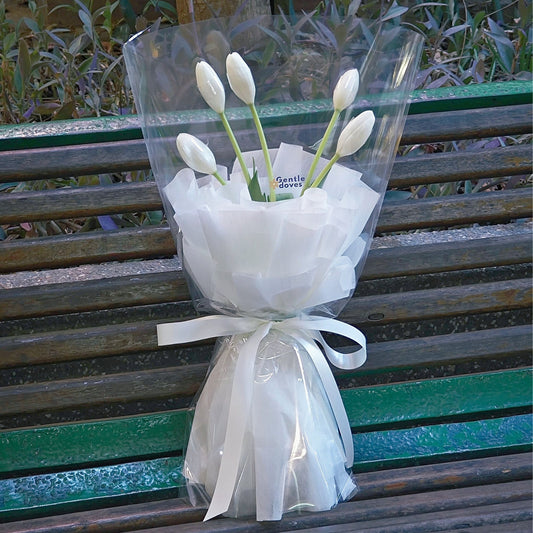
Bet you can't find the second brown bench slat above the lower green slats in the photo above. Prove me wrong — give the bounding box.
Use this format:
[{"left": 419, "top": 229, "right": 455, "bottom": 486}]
[{"left": 0, "top": 279, "right": 532, "bottom": 368}]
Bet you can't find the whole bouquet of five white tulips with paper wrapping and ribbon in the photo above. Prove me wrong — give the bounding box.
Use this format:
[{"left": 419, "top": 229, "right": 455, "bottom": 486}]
[{"left": 125, "top": 15, "right": 417, "bottom": 520}]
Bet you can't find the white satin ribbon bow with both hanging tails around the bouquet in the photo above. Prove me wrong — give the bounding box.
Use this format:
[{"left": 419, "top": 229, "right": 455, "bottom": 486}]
[{"left": 157, "top": 315, "right": 366, "bottom": 520}]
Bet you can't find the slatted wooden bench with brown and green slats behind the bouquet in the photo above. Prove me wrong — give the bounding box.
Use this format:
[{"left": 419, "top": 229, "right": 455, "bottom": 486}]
[{"left": 0, "top": 82, "right": 532, "bottom": 533}]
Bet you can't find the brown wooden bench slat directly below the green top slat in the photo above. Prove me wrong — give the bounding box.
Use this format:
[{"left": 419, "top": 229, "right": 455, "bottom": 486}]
[{"left": 0, "top": 105, "right": 532, "bottom": 182}]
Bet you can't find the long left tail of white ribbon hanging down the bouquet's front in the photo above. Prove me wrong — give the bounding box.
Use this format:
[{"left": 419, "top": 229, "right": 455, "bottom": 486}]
[{"left": 204, "top": 322, "right": 271, "bottom": 521}]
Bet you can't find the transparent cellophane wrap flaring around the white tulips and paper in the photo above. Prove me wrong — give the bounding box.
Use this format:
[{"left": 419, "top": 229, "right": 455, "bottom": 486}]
[{"left": 124, "top": 17, "right": 419, "bottom": 520}]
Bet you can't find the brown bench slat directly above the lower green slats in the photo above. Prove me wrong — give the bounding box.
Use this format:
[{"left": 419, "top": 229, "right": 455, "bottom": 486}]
[{"left": 0, "top": 326, "right": 531, "bottom": 416}]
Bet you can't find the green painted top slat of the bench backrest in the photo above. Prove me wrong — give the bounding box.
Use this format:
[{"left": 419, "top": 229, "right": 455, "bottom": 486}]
[{"left": 0, "top": 81, "right": 531, "bottom": 150}]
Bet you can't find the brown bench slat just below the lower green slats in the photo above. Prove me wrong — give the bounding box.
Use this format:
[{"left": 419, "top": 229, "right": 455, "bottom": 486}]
[{"left": 3, "top": 454, "right": 531, "bottom": 533}]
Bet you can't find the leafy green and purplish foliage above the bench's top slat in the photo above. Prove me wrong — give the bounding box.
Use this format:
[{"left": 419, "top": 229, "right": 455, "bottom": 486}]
[{"left": 0, "top": 0, "right": 533, "bottom": 123}]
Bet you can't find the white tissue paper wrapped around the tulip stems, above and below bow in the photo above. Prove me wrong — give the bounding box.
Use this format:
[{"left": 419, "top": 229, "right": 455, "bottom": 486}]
[{"left": 164, "top": 144, "right": 379, "bottom": 520}]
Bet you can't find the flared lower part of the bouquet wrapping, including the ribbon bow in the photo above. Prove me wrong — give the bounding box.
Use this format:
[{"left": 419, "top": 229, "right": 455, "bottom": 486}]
[{"left": 158, "top": 316, "right": 366, "bottom": 520}]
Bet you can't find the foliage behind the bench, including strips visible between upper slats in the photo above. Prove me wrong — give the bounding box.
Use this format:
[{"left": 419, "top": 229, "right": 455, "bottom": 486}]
[{"left": 0, "top": 0, "right": 533, "bottom": 241}]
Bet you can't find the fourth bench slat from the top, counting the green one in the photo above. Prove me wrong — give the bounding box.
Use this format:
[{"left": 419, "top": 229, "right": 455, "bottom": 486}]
[{"left": 0, "top": 189, "right": 532, "bottom": 272}]
